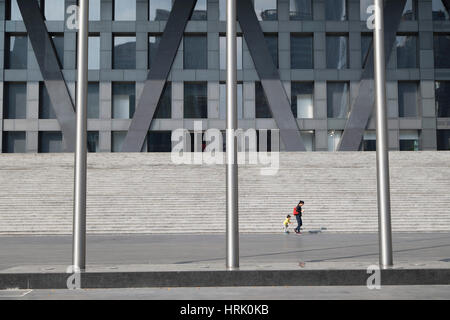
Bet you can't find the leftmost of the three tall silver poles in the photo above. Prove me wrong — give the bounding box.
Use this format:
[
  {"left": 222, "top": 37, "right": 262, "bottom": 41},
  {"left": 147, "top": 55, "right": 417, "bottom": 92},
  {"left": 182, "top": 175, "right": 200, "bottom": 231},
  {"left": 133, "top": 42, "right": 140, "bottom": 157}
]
[{"left": 73, "top": 0, "right": 89, "bottom": 270}]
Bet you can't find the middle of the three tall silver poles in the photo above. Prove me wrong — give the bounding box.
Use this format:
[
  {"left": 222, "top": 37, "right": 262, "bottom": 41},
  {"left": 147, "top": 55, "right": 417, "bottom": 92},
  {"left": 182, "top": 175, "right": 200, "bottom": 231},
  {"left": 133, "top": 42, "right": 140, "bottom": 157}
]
[{"left": 226, "top": 0, "right": 239, "bottom": 270}]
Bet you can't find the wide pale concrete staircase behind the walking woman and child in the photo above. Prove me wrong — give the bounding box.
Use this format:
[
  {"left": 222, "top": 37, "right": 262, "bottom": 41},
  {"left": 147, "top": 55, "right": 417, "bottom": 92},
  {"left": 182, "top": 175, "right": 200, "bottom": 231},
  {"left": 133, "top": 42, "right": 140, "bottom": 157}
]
[{"left": 0, "top": 152, "right": 450, "bottom": 235}]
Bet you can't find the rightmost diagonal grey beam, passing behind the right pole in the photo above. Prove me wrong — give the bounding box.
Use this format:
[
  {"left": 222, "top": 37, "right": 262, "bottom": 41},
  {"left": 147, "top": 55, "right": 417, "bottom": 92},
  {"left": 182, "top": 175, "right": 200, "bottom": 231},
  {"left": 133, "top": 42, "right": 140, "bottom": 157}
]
[{"left": 338, "top": 0, "right": 406, "bottom": 151}]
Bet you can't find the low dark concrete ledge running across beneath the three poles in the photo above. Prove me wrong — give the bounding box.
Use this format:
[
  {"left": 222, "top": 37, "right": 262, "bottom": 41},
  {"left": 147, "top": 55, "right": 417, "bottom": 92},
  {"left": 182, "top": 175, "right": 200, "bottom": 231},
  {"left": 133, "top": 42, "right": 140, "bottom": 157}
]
[{"left": 0, "top": 268, "right": 450, "bottom": 290}]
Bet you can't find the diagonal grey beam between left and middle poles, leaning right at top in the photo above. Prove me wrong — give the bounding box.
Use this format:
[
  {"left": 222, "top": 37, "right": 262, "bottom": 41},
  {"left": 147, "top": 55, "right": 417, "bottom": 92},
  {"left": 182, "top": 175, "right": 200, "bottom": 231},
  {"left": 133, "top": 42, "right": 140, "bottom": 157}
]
[{"left": 122, "top": 0, "right": 197, "bottom": 152}]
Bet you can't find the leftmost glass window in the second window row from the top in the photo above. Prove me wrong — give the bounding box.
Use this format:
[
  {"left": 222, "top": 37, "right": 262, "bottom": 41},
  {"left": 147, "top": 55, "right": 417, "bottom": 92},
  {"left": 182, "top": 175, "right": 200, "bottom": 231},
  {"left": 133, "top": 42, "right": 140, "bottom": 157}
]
[{"left": 5, "top": 35, "right": 28, "bottom": 69}]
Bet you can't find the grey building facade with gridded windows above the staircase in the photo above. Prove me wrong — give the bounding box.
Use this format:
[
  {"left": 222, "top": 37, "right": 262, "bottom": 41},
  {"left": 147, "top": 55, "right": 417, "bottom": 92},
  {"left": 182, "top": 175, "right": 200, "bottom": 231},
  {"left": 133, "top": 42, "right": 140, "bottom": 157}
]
[{"left": 0, "top": 0, "right": 450, "bottom": 153}]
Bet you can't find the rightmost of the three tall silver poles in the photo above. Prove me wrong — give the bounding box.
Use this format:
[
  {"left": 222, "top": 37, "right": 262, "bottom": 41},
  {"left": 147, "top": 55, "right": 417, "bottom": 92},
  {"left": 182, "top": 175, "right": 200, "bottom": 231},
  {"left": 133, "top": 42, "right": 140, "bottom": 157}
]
[{"left": 374, "top": 0, "right": 393, "bottom": 268}]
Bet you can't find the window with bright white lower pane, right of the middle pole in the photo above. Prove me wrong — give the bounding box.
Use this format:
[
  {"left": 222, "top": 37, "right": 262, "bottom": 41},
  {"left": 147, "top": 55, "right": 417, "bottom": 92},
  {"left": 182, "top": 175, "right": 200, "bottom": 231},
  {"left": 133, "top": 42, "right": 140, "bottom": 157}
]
[{"left": 291, "top": 82, "right": 314, "bottom": 119}]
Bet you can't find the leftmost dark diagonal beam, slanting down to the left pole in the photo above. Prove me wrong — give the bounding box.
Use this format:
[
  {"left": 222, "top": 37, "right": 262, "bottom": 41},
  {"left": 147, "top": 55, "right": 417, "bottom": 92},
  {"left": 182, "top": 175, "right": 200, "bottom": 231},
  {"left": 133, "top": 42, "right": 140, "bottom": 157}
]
[{"left": 17, "top": 0, "right": 76, "bottom": 152}]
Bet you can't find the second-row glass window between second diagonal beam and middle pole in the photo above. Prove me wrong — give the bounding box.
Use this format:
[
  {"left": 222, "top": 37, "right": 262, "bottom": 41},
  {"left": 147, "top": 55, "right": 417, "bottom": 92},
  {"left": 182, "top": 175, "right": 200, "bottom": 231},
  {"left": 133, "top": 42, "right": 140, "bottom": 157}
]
[{"left": 183, "top": 35, "right": 208, "bottom": 69}]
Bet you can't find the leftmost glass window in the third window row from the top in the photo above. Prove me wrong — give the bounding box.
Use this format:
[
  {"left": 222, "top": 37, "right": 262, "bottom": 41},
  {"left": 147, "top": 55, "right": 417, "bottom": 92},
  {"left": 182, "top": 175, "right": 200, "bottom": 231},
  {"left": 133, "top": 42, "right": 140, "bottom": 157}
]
[{"left": 3, "top": 83, "right": 27, "bottom": 119}]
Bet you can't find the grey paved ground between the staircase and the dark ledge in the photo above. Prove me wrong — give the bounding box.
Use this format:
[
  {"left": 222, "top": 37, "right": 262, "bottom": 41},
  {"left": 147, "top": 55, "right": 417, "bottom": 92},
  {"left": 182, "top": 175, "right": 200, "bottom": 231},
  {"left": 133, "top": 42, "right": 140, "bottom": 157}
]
[{"left": 0, "top": 233, "right": 450, "bottom": 270}]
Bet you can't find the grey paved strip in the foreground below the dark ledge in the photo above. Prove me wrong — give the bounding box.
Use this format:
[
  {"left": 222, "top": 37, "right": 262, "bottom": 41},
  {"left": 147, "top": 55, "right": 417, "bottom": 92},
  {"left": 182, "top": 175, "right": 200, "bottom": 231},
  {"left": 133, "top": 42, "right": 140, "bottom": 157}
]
[{"left": 0, "top": 286, "right": 450, "bottom": 300}]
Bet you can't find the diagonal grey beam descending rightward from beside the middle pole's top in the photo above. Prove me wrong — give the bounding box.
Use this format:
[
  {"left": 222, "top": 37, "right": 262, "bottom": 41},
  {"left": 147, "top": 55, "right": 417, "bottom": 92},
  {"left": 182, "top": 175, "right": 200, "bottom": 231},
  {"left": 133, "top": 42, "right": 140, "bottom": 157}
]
[{"left": 236, "top": 0, "right": 306, "bottom": 151}]
